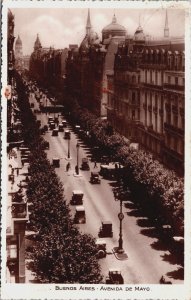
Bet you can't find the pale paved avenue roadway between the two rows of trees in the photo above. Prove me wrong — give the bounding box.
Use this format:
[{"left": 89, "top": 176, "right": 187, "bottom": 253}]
[{"left": 30, "top": 95, "right": 182, "bottom": 284}]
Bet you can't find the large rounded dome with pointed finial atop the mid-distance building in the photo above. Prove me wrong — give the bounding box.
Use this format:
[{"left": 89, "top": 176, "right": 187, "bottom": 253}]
[{"left": 102, "top": 14, "right": 127, "bottom": 41}]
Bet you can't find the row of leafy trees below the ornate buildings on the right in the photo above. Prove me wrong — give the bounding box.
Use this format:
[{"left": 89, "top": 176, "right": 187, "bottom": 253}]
[{"left": 64, "top": 99, "right": 184, "bottom": 234}]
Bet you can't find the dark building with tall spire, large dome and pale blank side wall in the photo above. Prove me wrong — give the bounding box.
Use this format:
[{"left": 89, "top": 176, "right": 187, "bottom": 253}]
[{"left": 67, "top": 10, "right": 126, "bottom": 117}]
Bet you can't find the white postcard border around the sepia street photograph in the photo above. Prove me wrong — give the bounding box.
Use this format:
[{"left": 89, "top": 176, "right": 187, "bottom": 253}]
[{"left": 1, "top": 0, "right": 191, "bottom": 300}]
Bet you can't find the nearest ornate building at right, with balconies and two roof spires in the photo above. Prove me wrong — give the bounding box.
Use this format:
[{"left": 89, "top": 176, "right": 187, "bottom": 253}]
[{"left": 108, "top": 13, "right": 185, "bottom": 173}]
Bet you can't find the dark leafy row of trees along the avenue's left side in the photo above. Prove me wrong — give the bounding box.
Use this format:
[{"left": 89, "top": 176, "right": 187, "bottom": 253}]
[{"left": 17, "top": 76, "right": 102, "bottom": 283}]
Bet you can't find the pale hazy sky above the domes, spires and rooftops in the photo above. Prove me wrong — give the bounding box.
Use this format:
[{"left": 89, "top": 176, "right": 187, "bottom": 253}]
[{"left": 11, "top": 8, "right": 185, "bottom": 55}]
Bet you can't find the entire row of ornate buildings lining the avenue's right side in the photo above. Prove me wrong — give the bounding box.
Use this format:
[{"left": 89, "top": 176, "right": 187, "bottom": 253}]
[{"left": 27, "top": 10, "right": 185, "bottom": 173}]
